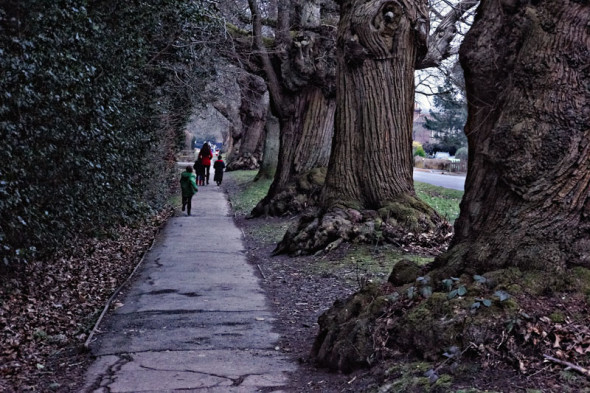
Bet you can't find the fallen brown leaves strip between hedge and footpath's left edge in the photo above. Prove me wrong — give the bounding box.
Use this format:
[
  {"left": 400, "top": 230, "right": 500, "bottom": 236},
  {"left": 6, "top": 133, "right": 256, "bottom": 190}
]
[{"left": 0, "top": 210, "right": 171, "bottom": 391}]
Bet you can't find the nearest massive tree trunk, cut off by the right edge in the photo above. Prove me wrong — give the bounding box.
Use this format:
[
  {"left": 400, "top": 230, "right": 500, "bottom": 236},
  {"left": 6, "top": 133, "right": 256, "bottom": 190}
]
[{"left": 437, "top": 0, "right": 590, "bottom": 274}]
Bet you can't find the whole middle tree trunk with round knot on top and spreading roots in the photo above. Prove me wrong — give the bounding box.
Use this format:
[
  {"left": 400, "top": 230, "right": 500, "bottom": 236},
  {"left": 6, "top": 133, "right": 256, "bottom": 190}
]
[{"left": 276, "top": 0, "right": 448, "bottom": 252}]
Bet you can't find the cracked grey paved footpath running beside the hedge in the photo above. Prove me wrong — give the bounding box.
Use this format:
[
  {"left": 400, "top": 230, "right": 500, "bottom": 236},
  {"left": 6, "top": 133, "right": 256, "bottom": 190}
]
[{"left": 82, "top": 174, "right": 296, "bottom": 393}]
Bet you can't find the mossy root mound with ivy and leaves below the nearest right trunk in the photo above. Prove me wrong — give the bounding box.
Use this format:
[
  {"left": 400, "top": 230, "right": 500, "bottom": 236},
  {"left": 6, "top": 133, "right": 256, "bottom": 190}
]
[{"left": 312, "top": 260, "right": 590, "bottom": 378}]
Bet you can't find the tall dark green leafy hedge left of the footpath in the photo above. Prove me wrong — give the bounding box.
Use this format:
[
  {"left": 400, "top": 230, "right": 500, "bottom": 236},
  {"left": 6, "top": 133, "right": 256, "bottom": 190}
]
[{"left": 0, "top": 0, "right": 218, "bottom": 265}]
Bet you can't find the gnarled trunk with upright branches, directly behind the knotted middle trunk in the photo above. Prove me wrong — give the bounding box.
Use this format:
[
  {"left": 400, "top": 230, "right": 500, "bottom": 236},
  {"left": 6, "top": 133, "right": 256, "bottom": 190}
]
[{"left": 249, "top": 0, "right": 335, "bottom": 216}]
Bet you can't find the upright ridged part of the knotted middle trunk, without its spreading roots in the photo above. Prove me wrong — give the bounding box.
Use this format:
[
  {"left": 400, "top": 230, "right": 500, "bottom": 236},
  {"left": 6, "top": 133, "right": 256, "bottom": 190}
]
[{"left": 322, "top": 0, "right": 428, "bottom": 210}]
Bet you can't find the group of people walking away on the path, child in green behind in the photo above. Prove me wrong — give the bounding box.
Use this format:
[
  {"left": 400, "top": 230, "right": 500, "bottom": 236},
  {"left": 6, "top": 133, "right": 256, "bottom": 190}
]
[{"left": 180, "top": 143, "right": 225, "bottom": 216}]
